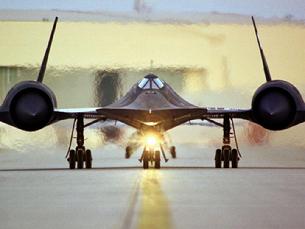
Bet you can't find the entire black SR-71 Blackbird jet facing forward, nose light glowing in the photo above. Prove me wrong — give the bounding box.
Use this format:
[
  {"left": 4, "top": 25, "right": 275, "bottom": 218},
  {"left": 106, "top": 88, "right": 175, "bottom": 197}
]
[{"left": 0, "top": 17, "right": 305, "bottom": 169}]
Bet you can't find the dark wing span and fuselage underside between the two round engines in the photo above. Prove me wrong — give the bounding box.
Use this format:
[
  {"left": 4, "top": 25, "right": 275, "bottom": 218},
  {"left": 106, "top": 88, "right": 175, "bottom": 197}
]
[{"left": 53, "top": 107, "right": 252, "bottom": 130}]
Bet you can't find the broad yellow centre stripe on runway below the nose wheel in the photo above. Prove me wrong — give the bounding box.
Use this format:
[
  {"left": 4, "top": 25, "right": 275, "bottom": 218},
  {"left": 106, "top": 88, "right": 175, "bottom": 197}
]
[{"left": 137, "top": 170, "right": 172, "bottom": 229}]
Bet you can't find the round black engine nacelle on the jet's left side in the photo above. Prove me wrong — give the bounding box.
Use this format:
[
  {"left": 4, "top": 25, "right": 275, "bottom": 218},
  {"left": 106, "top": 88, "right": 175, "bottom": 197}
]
[{"left": 3, "top": 81, "right": 57, "bottom": 131}]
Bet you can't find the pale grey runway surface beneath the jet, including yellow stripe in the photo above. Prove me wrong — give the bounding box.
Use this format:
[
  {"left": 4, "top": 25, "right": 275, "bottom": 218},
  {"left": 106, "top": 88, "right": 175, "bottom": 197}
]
[{"left": 0, "top": 147, "right": 305, "bottom": 229}]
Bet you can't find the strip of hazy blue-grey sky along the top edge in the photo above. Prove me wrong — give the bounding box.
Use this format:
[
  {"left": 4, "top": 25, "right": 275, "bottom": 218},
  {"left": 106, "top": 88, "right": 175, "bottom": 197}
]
[{"left": 0, "top": 0, "right": 305, "bottom": 19}]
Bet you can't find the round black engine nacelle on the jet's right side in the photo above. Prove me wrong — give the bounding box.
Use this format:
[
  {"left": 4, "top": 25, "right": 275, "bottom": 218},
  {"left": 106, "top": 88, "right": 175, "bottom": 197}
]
[{"left": 252, "top": 80, "right": 304, "bottom": 130}]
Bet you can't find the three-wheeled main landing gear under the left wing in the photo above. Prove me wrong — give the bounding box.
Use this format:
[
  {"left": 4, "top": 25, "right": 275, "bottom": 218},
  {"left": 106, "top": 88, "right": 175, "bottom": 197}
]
[{"left": 67, "top": 116, "right": 92, "bottom": 169}]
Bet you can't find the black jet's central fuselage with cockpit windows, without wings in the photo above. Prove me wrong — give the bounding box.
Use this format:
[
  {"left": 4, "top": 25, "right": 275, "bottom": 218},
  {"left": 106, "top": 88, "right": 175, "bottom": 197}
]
[{"left": 97, "top": 74, "right": 205, "bottom": 131}]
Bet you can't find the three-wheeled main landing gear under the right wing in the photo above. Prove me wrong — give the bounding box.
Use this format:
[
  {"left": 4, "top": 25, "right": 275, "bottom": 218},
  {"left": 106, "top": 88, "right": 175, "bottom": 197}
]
[{"left": 215, "top": 115, "right": 240, "bottom": 168}]
